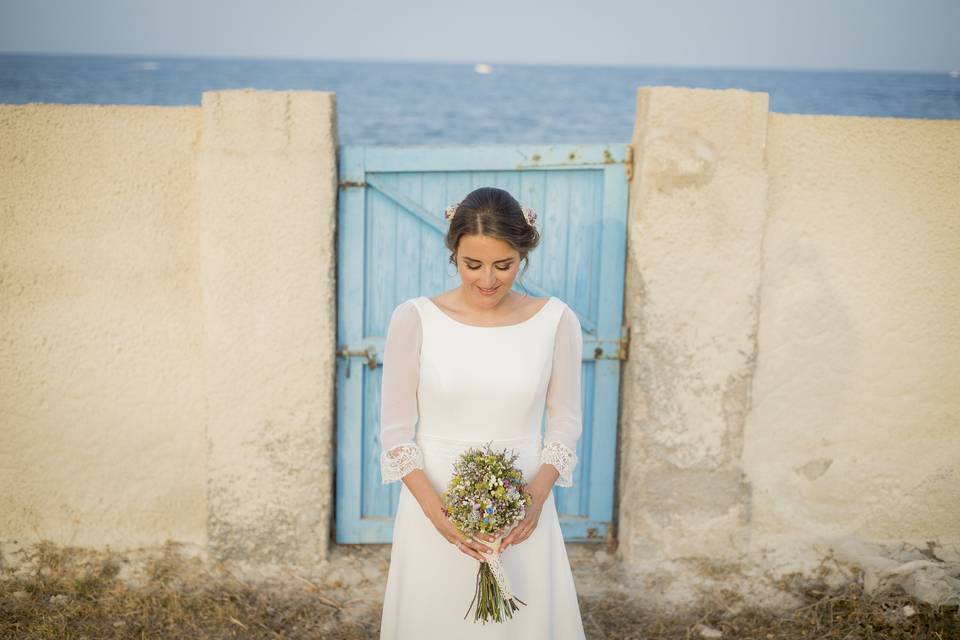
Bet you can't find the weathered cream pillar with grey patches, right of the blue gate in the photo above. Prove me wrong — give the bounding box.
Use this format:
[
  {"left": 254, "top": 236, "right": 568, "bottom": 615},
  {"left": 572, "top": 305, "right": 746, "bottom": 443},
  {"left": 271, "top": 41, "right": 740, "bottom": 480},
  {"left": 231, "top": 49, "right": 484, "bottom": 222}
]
[{"left": 618, "top": 87, "right": 768, "bottom": 567}]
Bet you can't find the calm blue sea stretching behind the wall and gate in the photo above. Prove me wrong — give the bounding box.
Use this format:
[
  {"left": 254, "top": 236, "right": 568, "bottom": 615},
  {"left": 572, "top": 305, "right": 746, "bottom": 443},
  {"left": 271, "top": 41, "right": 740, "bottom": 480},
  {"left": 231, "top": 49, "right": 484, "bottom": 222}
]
[{"left": 0, "top": 54, "right": 960, "bottom": 144}]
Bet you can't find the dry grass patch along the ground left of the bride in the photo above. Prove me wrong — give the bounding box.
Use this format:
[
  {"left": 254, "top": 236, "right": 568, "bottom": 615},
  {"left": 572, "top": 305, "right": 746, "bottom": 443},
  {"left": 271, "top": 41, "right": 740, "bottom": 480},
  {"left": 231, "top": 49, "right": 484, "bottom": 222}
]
[{"left": 0, "top": 543, "right": 379, "bottom": 640}]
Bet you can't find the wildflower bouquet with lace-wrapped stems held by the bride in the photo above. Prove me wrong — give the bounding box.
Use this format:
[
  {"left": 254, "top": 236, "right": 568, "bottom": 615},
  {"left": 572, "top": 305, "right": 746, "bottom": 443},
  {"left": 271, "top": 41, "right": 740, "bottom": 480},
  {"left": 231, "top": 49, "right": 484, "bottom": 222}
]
[{"left": 441, "top": 443, "right": 533, "bottom": 624}]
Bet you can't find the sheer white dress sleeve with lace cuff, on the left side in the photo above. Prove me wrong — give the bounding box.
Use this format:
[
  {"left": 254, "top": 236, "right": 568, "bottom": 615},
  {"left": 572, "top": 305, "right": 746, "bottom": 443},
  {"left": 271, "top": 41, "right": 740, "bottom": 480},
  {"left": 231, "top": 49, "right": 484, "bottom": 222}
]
[{"left": 380, "top": 300, "right": 424, "bottom": 484}]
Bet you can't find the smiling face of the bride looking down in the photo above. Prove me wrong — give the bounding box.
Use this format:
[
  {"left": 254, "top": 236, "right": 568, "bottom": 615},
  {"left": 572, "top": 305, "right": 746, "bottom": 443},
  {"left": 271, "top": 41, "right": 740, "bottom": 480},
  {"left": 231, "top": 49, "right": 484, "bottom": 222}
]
[{"left": 457, "top": 235, "right": 520, "bottom": 306}]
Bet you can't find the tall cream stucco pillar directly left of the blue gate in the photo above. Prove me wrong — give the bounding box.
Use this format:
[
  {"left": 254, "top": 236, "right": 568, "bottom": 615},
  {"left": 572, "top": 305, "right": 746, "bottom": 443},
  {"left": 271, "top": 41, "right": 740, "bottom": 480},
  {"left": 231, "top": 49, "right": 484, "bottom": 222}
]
[{"left": 198, "top": 90, "right": 337, "bottom": 564}]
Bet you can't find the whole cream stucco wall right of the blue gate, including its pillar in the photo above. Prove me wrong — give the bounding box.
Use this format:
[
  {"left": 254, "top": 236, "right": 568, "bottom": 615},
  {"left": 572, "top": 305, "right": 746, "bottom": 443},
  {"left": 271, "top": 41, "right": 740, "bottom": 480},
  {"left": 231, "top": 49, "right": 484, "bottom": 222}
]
[{"left": 618, "top": 87, "right": 960, "bottom": 571}]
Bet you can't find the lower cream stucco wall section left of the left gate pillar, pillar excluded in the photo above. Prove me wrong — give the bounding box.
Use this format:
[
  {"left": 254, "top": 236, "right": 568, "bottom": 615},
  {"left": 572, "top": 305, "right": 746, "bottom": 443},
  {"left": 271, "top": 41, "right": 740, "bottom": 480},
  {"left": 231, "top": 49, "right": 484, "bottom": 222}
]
[{"left": 0, "top": 105, "right": 207, "bottom": 548}]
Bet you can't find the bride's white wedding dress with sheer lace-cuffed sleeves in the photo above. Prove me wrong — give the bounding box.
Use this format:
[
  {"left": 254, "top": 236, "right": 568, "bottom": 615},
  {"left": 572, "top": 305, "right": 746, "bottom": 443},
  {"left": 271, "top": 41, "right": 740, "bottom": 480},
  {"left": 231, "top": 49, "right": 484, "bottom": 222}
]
[{"left": 380, "top": 296, "right": 585, "bottom": 640}]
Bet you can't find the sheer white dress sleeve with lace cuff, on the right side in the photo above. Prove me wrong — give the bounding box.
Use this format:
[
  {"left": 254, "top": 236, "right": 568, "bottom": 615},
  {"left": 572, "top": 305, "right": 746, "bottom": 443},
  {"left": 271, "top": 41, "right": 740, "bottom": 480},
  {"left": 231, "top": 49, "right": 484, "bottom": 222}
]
[{"left": 540, "top": 307, "right": 583, "bottom": 487}]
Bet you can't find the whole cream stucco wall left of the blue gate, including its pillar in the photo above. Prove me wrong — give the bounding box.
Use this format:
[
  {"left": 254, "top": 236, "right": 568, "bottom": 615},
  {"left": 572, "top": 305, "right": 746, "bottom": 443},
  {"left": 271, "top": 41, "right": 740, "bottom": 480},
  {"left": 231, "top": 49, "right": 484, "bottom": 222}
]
[{"left": 0, "top": 90, "right": 337, "bottom": 564}]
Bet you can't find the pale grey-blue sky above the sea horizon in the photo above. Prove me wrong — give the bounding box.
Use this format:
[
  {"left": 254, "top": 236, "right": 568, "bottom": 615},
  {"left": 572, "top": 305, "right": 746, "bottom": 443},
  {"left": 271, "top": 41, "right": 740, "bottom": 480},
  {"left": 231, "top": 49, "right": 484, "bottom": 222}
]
[{"left": 0, "top": 0, "right": 960, "bottom": 71}]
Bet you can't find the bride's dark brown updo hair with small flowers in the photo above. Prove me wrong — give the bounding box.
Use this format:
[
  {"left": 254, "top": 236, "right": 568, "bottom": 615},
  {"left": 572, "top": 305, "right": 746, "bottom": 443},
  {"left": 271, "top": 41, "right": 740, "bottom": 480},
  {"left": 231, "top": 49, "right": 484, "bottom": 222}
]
[{"left": 444, "top": 187, "right": 540, "bottom": 272}]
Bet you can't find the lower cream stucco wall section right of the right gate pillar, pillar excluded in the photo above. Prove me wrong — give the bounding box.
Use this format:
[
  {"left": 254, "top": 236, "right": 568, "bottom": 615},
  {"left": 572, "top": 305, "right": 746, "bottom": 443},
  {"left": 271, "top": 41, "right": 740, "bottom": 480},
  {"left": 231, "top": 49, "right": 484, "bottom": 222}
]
[{"left": 744, "top": 114, "right": 960, "bottom": 557}]
